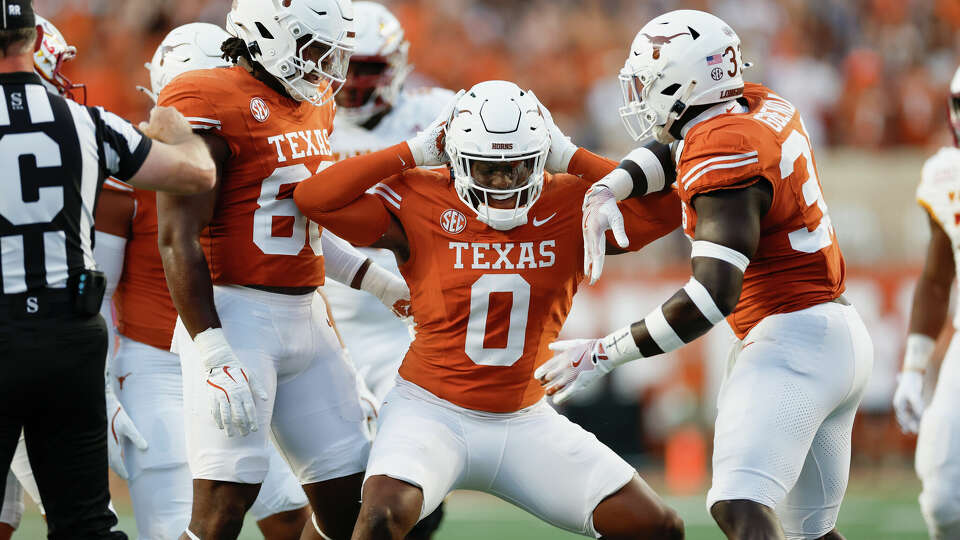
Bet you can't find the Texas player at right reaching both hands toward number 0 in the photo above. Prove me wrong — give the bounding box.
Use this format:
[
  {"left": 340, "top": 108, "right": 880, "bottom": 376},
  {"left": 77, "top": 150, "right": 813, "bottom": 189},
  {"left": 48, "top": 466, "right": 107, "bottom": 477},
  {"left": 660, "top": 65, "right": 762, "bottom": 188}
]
[{"left": 536, "top": 10, "right": 873, "bottom": 539}]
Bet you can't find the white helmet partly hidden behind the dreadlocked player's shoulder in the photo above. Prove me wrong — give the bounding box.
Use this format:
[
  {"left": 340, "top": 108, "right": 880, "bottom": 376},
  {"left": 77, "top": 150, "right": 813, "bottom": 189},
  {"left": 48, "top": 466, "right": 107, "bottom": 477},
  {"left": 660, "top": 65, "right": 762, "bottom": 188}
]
[{"left": 144, "top": 23, "right": 230, "bottom": 95}]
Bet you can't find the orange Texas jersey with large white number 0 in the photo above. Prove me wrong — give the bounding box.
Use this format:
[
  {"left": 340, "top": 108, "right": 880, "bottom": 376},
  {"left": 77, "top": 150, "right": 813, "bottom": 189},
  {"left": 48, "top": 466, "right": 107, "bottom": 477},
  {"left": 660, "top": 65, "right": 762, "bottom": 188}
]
[{"left": 373, "top": 171, "right": 679, "bottom": 412}]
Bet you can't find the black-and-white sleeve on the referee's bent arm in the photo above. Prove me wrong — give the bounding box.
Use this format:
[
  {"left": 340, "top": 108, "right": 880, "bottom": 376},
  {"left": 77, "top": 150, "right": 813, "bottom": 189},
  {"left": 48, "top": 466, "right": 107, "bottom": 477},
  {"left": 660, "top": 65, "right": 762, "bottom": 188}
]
[{"left": 89, "top": 107, "right": 153, "bottom": 182}]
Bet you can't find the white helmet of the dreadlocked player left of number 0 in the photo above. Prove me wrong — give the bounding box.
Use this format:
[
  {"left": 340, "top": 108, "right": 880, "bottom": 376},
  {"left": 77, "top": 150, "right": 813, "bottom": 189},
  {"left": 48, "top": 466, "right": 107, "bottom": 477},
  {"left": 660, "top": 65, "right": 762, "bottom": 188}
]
[{"left": 227, "top": 0, "right": 356, "bottom": 106}]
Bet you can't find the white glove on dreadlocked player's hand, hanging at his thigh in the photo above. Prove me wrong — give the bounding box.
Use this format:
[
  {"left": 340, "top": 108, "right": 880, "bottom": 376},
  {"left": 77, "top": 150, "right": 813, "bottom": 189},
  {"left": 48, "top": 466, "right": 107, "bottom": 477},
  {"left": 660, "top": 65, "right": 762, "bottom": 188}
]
[{"left": 193, "top": 328, "right": 269, "bottom": 437}]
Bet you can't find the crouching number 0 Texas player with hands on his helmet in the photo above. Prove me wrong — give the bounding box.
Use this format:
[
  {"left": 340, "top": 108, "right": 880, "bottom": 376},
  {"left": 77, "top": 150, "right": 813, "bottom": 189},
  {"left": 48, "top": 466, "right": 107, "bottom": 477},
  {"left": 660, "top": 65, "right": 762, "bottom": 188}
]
[{"left": 294, "top": 81, "right": 683, "bottom": 540}]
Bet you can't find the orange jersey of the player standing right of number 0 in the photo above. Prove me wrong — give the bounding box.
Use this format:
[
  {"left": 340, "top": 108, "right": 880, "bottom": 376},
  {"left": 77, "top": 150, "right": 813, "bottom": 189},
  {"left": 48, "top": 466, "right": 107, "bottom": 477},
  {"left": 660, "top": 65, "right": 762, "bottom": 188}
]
[{"left": 677, "top": 83, "right": 845, "bottom": 339}]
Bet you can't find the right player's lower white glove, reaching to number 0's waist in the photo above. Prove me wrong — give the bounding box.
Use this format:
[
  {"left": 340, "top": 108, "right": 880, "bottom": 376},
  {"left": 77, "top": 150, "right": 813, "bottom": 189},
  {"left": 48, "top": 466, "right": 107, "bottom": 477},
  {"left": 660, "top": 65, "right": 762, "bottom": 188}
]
[{"left": 533, "top": 339, "right": 616, "bottom": 405}]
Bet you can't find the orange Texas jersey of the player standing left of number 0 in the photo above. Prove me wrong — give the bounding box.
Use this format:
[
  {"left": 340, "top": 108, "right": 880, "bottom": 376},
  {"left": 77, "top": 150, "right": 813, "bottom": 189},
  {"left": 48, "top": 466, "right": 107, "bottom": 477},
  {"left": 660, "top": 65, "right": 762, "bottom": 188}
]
[{"left": 160, "top": 67, "right": 334, "bottom": 287}]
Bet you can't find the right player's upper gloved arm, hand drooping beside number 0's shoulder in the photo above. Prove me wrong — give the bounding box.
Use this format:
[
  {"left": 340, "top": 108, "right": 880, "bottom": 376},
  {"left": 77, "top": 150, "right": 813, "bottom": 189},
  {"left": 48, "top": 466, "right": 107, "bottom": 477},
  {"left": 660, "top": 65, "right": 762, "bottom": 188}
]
[{"left": 571, "top": 142, "right": 677, "bottom": 285}]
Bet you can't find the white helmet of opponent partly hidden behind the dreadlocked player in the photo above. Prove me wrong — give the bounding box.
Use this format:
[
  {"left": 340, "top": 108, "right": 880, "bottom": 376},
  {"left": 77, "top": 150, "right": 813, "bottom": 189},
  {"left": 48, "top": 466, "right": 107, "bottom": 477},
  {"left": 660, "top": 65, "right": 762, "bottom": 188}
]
[{"left": 337, "top": 2, "right": 413, "bottom": 124}]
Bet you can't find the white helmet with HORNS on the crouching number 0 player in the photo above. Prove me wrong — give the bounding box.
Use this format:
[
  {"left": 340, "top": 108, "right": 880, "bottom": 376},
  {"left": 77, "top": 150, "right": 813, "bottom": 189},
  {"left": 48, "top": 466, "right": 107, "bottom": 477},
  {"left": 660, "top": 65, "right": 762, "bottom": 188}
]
[{"left": 445, "top": 81, "right": 550, "bottom": 231}]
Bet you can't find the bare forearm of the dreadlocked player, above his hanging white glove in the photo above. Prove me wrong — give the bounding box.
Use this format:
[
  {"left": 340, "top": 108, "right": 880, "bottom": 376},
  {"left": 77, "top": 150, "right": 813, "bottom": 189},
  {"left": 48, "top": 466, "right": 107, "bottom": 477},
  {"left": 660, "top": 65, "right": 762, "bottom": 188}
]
[{"left": 160, "top": 238, "right": 220, "bottom": 338}]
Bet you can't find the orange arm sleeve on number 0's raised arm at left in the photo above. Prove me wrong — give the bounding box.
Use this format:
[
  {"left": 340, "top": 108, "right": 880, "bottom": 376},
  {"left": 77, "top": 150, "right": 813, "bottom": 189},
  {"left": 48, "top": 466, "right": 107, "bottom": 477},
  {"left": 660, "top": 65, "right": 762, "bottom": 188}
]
[{"left": 293, "top": 143, "right": 413, "bottom": 246}]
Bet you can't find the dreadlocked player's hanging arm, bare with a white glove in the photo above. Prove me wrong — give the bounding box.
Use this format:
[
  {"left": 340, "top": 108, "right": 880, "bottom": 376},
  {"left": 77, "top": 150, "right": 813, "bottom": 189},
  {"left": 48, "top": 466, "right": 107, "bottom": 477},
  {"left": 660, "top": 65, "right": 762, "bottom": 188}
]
[{"left": 157, "top": 135, "right": 268, "bottom": 437}]
